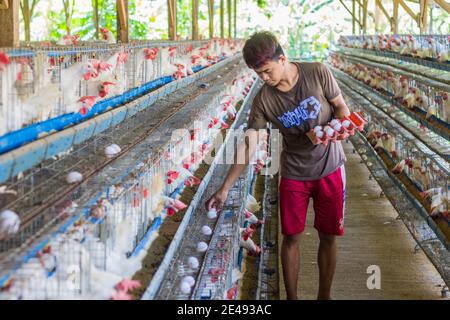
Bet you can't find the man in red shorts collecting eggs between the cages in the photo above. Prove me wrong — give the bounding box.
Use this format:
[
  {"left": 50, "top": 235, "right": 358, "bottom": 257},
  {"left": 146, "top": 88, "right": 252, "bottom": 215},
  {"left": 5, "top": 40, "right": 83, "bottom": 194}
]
[{"left": 206, "top": 32, "right": 350, "bottom": 299}]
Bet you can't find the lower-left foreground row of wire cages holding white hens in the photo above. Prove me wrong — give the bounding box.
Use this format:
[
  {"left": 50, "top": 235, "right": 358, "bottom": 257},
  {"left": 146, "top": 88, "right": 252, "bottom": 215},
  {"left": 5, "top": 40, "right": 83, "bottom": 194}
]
[{"left": 0, "top": 71, "right": 254, "bottom": 299}]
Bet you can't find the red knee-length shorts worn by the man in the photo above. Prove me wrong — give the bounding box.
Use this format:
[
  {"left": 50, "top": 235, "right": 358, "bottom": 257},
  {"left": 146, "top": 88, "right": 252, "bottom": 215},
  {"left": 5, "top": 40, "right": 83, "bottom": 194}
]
[{"left": 280, "top": 165, "right": 345, "bottom": 235}]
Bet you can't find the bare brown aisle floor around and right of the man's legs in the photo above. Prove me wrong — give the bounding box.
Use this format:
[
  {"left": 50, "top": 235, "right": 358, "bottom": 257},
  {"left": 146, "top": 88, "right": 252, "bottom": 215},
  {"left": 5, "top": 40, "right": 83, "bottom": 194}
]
[{"left": 279, "top": 142, "right": 444, "bottom": 300}]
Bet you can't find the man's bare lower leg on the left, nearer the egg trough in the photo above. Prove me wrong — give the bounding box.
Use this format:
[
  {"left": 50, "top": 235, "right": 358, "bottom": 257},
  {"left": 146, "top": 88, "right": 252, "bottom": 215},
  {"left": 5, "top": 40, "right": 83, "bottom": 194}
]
[{"left": 281, "top": 234, "right": 301, "bottom": 300}]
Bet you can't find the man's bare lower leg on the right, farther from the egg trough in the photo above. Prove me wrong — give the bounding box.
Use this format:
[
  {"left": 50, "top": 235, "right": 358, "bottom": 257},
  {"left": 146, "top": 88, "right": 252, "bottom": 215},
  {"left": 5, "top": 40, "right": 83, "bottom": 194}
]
[{"left": 317, "top": 232, "right": 336, "bottom": 300}]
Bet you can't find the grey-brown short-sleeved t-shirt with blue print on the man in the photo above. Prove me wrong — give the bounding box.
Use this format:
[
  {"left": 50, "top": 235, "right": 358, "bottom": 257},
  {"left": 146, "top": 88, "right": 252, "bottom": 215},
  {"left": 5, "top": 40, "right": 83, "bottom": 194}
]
[{"left": 248, "top": 62, "right": 346, "bottom": 181}]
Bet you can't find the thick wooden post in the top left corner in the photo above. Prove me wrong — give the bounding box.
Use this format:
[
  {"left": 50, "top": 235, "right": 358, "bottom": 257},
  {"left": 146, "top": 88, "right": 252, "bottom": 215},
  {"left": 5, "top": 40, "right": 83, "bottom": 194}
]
[{"left": 0, "top": 0, "right": 20, "bottom": 47}]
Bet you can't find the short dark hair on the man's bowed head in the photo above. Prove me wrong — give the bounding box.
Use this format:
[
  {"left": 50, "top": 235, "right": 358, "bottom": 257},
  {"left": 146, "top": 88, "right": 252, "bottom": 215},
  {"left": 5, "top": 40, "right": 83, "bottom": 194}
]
[{"left": 242, "top": 31, "right": 284, "bottom": 69}]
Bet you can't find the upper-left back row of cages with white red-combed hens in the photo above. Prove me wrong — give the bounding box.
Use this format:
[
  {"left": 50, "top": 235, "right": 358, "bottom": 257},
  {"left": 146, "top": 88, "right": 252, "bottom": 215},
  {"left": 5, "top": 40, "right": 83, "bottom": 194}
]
[{"left": 0, "top": 39, "right": 242, "bottom": 141}]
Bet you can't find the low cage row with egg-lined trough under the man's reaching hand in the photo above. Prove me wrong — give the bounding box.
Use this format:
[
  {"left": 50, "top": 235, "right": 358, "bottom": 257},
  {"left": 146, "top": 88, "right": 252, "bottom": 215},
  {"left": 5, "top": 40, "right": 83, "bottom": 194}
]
[{"left": 151, "top": 85, "right": 271, "bottom": 300}]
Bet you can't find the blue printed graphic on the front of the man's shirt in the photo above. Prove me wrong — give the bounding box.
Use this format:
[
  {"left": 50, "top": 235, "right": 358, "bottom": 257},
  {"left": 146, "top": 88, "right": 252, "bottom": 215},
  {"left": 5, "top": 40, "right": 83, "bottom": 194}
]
[{"left": 277, "top": 96, "right": 322, "bottom": 129}]
